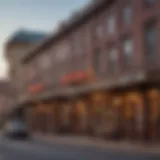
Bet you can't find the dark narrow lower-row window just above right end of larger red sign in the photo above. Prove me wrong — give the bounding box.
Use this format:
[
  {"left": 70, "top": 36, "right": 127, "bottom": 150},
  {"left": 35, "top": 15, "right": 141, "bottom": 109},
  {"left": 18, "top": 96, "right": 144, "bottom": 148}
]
[{"left": 93, "top": 49, "right": 101, "bottom": 74}]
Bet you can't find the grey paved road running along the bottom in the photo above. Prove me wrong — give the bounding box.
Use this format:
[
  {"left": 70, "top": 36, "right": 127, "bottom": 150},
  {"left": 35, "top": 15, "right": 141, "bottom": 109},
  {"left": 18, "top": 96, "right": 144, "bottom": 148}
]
[{"left": 0, "top": 138, "right": 160, "bottom": 160}]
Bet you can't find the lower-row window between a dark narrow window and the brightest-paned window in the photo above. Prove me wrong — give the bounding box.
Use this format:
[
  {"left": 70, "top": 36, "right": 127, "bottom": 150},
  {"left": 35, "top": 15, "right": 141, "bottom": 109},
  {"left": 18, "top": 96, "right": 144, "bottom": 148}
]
[{"left": 108, "top": 48, "right": 118, "bottom": 72}]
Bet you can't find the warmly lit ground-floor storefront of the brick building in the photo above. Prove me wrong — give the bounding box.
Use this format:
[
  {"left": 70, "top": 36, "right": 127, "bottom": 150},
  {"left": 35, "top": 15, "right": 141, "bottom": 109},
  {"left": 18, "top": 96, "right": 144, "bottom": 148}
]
[{"left": 23, "top": 74, "right": 160, "bottom": 140}]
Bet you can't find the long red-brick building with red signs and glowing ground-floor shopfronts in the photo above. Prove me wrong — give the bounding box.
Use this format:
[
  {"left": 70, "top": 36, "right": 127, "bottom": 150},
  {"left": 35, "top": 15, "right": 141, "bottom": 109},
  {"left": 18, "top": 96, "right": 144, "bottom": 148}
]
[{"left": 16, "top": 0, "right": 160, "bottom": 140}]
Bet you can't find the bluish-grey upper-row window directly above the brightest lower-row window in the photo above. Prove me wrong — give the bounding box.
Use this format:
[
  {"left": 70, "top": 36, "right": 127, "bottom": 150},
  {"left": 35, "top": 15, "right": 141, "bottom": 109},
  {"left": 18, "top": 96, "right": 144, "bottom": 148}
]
[{"left": 123, "top": 3, "right": 132, "bottom": 24}]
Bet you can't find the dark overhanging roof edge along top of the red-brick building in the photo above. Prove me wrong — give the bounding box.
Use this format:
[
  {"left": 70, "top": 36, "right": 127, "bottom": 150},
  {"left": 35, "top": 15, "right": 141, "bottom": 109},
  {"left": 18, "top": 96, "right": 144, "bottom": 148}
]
[{"left": 21, "top": 0, "right": 115, "bottom": 63}]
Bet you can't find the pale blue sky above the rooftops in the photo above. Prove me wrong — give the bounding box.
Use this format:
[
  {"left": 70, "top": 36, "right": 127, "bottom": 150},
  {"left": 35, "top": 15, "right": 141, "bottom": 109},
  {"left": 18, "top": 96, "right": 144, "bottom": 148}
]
[{"left": 0, "top": 0, "right": 89, "bottom": 78}]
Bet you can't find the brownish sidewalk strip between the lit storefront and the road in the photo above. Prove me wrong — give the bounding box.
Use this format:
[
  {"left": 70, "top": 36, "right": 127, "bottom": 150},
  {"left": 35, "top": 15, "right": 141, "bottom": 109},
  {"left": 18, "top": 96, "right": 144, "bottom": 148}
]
[{"left": 33, "top": 134, "right": 160, "bottom": 155}]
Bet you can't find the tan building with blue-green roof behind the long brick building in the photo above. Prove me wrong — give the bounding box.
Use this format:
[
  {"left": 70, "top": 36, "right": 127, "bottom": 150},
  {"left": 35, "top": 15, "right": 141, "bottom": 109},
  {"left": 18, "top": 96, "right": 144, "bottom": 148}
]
[{"left": 4, "top": 29, "right": 46, "bottom": 105}]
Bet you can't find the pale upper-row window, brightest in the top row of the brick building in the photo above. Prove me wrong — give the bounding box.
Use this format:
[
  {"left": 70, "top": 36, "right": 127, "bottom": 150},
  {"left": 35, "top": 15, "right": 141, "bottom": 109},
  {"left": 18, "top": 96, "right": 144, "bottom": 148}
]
[{"left": 107, "top": 14, "right": 116, "bottom": 33}]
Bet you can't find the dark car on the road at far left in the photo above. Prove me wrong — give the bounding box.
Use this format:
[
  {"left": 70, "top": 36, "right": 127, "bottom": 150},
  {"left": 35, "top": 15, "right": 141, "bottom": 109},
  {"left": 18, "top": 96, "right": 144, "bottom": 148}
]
[{"left": 3, "top": 120, "right": 29, "bottom": 139}]
